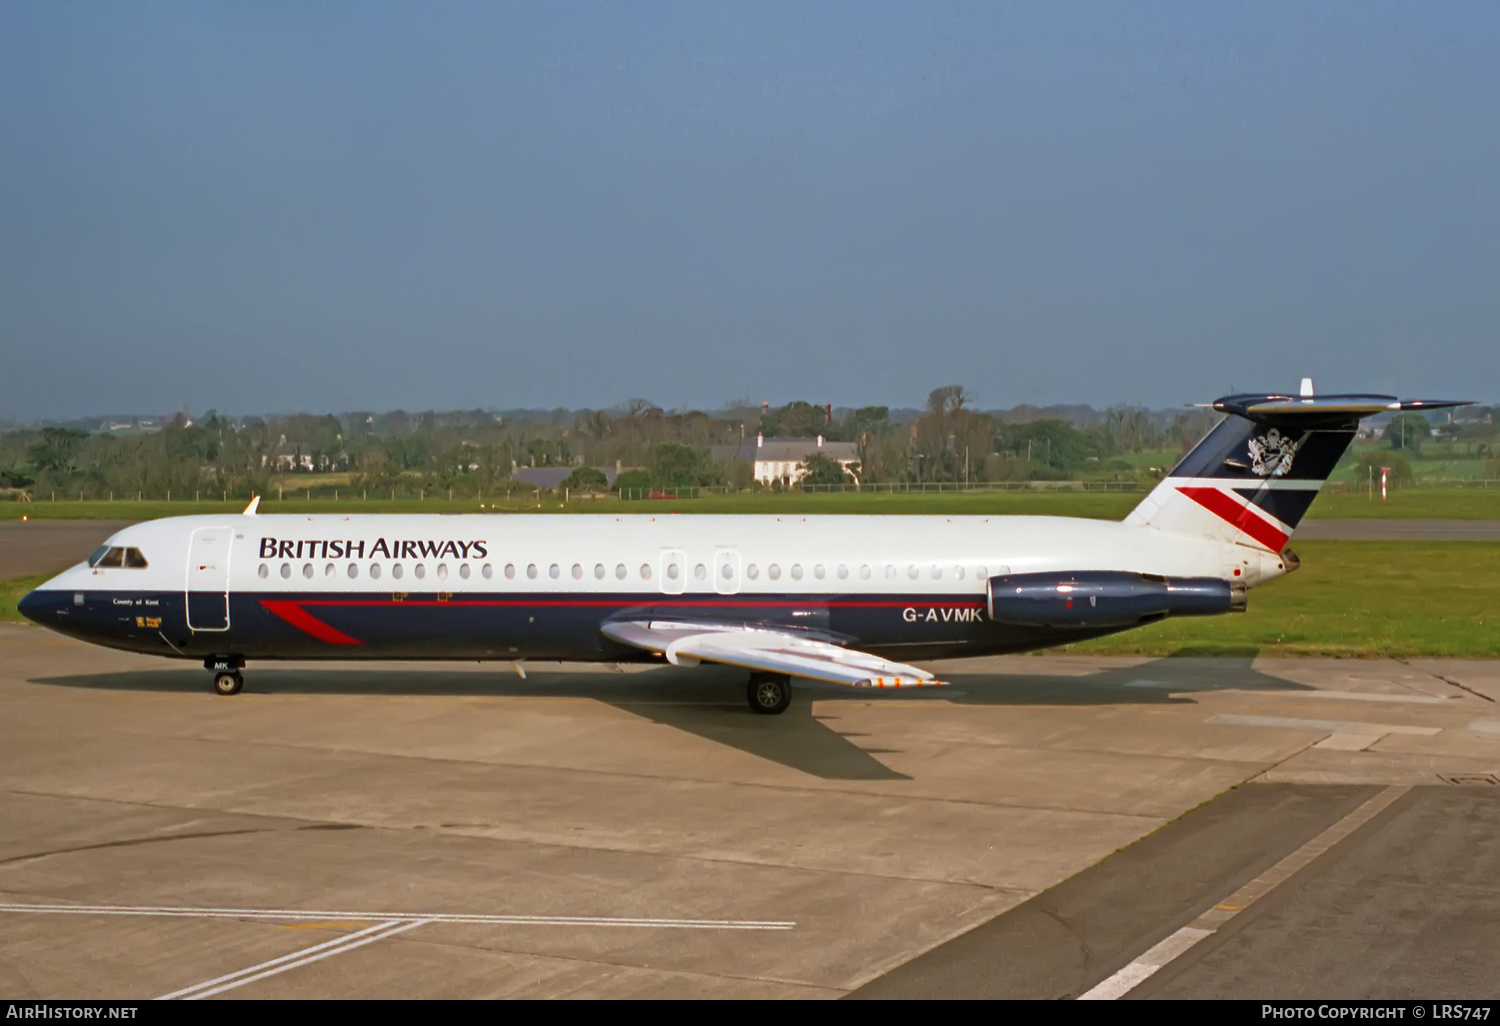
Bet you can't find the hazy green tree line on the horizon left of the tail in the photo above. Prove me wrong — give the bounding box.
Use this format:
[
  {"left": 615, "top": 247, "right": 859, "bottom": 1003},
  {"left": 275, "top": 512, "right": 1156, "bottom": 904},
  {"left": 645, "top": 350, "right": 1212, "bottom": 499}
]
[{"left": 0, "top": 386, "right": 1493, "bottom": 498}]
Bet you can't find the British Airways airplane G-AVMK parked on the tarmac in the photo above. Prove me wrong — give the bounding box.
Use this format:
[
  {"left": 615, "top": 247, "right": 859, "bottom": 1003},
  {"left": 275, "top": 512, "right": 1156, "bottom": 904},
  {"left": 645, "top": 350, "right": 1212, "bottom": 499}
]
[{"left": 20, "top": 378, "right": 1469, "bottom": 714}]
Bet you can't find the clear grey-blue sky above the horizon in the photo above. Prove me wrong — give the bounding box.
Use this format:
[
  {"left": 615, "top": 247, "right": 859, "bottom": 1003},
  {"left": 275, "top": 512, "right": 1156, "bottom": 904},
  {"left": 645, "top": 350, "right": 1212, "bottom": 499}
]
[{"left": 0, "top": 0, "right": 1500, "bottom": 419}]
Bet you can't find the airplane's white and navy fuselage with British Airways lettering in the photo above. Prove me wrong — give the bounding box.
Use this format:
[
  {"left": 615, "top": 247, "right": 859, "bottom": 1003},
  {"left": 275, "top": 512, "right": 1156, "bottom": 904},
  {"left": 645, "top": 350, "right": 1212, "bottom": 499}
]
[{"left": 14, "top": 515, "right": 1284, "bottom": 662}]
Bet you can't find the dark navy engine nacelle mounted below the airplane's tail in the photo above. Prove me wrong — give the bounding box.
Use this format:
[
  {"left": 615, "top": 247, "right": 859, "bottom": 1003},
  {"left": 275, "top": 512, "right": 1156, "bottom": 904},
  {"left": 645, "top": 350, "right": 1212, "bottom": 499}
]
[{"left": 989, "top": 570, "right": 1245, "bottom": 627}]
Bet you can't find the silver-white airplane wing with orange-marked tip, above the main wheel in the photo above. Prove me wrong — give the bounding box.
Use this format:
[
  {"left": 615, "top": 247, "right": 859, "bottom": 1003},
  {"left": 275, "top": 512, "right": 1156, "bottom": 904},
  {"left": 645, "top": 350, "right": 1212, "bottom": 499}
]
[{"left": 600, "top": 620, "right": 945, "bottom": 687}]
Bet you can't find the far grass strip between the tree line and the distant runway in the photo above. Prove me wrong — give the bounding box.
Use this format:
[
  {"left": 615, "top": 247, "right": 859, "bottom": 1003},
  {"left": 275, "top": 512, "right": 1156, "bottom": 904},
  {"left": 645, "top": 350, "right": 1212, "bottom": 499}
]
[{"left": 0, "top": 488, "right": 1500, "bottom": 521}]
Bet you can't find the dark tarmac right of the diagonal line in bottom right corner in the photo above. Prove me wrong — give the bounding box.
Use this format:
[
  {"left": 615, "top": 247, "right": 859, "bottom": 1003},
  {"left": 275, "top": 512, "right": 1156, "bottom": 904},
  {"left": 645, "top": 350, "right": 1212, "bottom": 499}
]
[{"left": 1130, "top": 785, "right": 1500, "bottom": 1001}]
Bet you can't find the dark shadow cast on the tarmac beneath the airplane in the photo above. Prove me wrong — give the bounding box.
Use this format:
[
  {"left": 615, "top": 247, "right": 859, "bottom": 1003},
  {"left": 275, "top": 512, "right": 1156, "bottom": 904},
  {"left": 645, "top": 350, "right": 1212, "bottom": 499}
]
[{"left": 30, "top": 657, "right": 1310, "bottom": 780}]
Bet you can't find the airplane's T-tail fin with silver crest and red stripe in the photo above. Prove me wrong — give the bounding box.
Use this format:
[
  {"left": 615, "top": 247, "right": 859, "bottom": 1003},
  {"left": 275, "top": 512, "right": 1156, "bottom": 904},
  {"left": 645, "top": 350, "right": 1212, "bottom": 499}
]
[{"left": 1125, "top": 378, "right": 1469, "bottom": 552}]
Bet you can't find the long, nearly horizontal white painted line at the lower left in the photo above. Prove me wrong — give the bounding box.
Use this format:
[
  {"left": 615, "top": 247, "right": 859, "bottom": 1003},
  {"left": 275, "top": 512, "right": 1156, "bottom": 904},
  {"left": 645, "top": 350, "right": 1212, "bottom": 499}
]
[{"left": 0, "top": 902, "right": 797, "bottom": 930}]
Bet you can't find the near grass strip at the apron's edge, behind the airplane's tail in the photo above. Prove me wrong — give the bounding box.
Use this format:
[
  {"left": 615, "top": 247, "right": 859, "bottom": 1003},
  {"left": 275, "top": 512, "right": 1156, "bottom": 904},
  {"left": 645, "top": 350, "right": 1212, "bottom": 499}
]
[{"left": 0, "top": 542, "right": 1500, "bottom": 659}]
